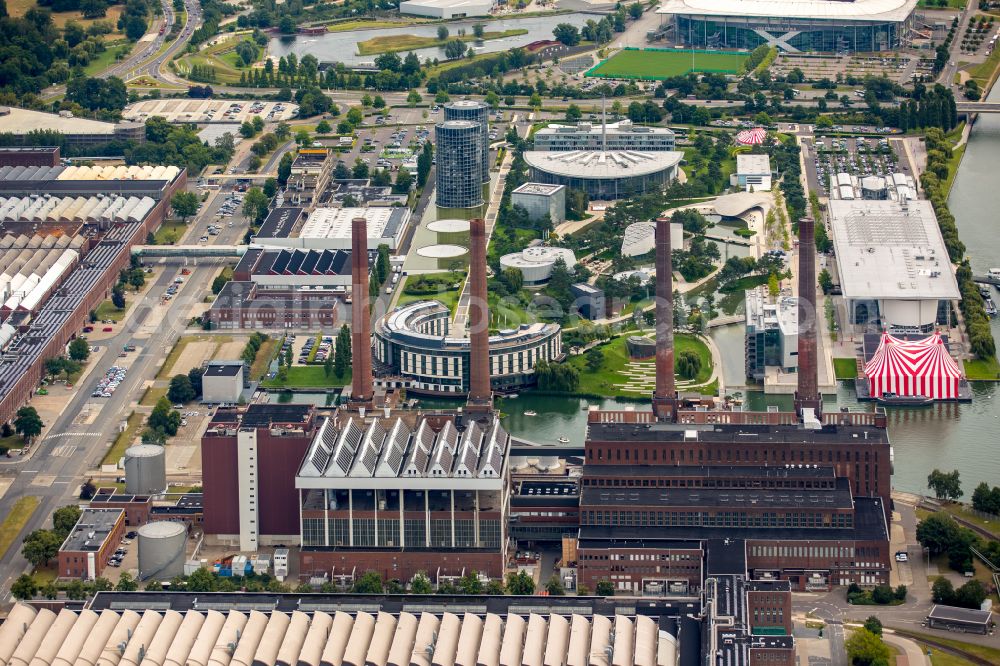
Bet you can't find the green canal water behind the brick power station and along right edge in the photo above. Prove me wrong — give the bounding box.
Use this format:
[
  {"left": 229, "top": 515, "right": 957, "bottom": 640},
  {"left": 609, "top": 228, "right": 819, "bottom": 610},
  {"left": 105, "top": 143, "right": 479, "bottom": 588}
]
[{"left": 502, "top": 97, "right": 1000, "bottom": 492}]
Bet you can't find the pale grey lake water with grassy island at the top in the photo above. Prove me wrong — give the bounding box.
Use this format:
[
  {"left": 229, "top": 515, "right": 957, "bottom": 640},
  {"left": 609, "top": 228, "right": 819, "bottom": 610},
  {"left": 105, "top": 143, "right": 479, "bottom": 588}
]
[{"left": 268, "top": 13, "right": 599, "bottom": 65}]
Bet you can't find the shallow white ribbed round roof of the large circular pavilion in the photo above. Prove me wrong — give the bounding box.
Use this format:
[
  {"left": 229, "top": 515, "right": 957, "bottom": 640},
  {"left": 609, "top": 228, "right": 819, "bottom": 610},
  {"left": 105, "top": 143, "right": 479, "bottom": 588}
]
[{"left": 524, "top": 150, "right": 684, "bottom": 180}]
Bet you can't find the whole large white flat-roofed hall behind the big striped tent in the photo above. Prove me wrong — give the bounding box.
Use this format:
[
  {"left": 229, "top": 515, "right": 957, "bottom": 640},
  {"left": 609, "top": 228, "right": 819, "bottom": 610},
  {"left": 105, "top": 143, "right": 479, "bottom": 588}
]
[{"left": 827, "top": 199, "right": 960, "bottom": 334}]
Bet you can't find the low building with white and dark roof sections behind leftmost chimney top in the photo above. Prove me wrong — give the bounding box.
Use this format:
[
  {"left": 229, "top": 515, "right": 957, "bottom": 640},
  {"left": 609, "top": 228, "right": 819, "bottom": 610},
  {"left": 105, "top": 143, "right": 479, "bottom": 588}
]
[{"left": 250, "top": 206, "right": 410, "bottom": 251}]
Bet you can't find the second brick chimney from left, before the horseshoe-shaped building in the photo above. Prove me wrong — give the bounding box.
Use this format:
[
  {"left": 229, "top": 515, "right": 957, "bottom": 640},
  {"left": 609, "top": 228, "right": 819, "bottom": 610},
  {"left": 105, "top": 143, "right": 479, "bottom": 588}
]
[{"left": 469, "top": 218, "right": 493, "bottom": 410}]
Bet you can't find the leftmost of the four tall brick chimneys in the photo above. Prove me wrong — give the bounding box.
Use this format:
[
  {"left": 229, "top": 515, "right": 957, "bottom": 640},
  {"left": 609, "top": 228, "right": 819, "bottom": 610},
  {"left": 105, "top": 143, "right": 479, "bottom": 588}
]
[{"left": 350, "top": 217, "right": 374, "bottom": 406}]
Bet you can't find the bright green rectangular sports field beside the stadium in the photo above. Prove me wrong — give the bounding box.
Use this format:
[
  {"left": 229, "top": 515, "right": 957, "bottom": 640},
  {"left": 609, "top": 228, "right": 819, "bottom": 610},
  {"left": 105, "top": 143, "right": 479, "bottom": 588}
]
[{"left": 586, "top": 49, "right": 747, "bottom": 80}]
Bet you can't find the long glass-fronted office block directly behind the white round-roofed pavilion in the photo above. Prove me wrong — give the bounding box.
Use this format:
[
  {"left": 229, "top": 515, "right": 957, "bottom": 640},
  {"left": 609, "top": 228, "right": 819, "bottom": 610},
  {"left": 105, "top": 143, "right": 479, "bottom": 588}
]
[{"left": 532, "top": 120, "right": 677, "bottom": 153}]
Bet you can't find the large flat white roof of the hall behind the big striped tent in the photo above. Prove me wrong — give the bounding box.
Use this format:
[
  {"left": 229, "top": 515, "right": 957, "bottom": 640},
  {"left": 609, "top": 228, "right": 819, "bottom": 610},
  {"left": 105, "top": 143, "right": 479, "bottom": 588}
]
[{"left": 827, "top": 199, "right": 960, "bottom": 300}]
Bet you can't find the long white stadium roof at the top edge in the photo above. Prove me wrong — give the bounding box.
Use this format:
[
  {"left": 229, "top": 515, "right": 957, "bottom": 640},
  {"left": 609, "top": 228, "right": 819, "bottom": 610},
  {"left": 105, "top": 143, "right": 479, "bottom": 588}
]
[{"left": 656, "top": 0, "right": 917, "bottom": 22}]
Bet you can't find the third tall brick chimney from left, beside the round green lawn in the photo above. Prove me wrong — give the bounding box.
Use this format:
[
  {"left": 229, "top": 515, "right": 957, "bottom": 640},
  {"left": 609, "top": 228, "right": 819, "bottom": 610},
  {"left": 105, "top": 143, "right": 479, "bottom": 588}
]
[{"left": 653, "top": 218, "right": 677, "bottom": 421}]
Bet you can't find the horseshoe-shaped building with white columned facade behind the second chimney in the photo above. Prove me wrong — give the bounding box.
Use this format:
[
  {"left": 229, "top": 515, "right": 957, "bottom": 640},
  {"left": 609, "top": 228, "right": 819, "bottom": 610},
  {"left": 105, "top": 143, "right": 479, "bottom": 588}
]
[{"left": 374, "top": 300, "right": 563, "bottom": 395}]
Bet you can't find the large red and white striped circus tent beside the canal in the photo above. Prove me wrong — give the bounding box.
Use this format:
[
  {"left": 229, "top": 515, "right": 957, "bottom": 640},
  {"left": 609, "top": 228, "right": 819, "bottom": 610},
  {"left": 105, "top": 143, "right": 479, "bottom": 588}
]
[{"left": 865, "top": 332, "right": 962, "bottom": 400}]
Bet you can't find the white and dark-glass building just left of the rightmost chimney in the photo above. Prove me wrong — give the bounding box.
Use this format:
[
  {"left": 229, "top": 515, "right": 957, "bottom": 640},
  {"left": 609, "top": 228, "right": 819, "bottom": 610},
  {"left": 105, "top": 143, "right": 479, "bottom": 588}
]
[{"left": 745, "top": 286, "right": 799, "bottom": 382}]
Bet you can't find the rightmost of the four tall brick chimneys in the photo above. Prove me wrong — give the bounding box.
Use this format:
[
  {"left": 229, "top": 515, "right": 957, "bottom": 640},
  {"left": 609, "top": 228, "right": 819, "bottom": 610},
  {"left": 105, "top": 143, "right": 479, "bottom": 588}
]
[{"left": 795, "top": 217, "right": 823, "bottom": 418}]
